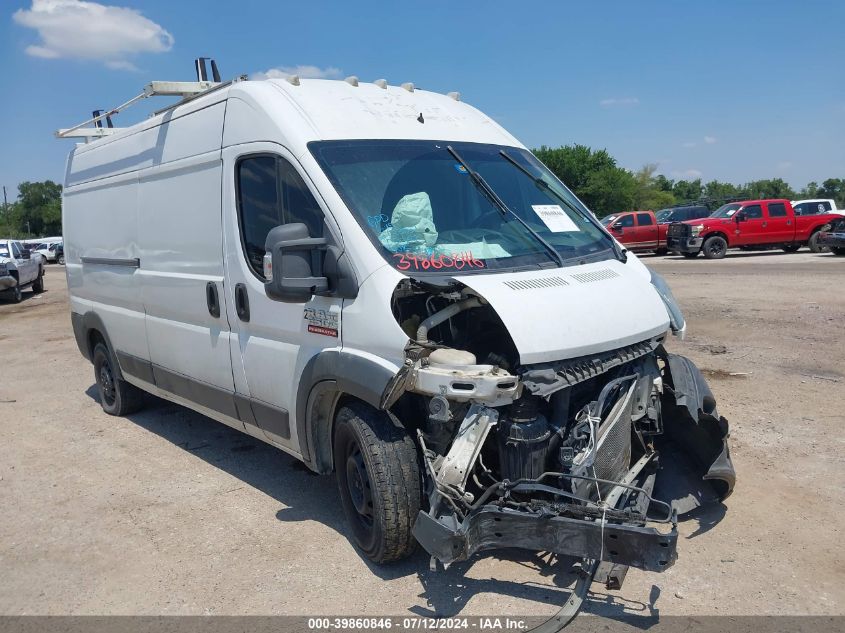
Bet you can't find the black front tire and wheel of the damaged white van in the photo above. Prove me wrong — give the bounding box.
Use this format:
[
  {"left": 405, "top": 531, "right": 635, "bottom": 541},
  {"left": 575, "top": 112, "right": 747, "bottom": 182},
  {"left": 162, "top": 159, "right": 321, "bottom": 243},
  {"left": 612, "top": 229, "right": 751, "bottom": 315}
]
[{"left": 334, "top": 403, "right": 421, "bottom": 563}]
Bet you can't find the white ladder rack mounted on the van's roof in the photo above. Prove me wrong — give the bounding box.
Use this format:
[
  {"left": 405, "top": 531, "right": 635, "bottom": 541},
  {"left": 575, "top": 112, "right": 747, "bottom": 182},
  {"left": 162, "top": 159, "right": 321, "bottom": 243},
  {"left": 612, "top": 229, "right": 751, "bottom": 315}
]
[{"left": 56, "top": 57, "right": 232, "bottom": 143}]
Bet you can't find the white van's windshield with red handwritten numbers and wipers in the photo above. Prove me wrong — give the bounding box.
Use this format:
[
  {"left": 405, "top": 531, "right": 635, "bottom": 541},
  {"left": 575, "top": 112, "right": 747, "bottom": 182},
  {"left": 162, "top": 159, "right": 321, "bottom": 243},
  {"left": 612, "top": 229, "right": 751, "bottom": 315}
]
[{"left": 309, "top": 140, "right": 614, "bottom": 272}]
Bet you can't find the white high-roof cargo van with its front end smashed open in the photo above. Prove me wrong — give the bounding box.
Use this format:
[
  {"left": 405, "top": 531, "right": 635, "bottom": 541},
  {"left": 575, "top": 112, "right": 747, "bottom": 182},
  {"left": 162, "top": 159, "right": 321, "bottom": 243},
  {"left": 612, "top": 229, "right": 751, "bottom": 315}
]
[{"left": 64, "top": 70, "right": 734, "bottom": 596}]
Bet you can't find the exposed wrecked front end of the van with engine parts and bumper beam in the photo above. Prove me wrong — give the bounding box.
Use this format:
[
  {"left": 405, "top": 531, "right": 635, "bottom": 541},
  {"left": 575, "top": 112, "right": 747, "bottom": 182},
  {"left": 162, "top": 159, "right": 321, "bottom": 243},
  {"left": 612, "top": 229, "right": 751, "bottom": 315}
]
[{"left": 382, "top": 279, "right": 735, "bottom": 588}]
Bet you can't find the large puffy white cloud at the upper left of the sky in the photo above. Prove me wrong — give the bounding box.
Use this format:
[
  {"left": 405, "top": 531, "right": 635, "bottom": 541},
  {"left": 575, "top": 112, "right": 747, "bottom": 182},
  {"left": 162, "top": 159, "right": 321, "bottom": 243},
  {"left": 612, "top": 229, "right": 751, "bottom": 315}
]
[{"left": 12, "top": 0, "right": 173, "bottom": 70}]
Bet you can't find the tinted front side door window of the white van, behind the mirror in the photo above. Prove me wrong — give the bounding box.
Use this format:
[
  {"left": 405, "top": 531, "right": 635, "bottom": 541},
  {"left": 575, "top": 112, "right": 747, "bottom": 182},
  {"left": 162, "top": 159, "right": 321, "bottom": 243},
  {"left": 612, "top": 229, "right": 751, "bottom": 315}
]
[{"left": 236, "top": 155, "right": 324, "bottom": 279}]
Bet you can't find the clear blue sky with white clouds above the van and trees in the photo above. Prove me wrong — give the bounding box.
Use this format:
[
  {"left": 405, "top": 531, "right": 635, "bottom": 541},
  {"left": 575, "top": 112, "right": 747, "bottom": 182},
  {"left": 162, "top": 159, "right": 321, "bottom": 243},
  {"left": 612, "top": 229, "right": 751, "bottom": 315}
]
[{"left": 0, "top": 0, "right": 845, "bottom": 197}]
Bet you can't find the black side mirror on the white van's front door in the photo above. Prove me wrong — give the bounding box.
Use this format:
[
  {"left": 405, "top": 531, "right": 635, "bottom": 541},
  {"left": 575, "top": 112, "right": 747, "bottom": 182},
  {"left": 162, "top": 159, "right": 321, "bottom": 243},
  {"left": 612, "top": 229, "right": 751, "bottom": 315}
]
[{"left": 264, "top": 222, "right": 329, "bottom": 303}]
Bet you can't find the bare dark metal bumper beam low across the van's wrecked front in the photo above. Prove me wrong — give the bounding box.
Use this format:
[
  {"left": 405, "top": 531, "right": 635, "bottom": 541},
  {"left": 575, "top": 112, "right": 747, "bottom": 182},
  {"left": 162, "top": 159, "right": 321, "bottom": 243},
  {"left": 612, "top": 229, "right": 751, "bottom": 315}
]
[{"left": 413, "top": 505, "right": 678, "bottom": 571}]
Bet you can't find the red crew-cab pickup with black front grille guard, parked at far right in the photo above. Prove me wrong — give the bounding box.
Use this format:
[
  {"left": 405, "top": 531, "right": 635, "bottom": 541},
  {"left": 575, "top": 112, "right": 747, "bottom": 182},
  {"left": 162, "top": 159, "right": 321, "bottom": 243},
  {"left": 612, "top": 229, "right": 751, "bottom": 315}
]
[{"left": 666, "top": 200, "right": 842, "bottom": 259}]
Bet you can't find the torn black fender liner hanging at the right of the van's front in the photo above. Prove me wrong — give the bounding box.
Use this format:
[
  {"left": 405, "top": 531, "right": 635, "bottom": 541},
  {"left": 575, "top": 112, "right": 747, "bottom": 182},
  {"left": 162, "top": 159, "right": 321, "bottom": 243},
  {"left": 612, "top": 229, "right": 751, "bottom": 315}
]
[{"left": 655, "top": 354, "right": 736, "bottom": 514}]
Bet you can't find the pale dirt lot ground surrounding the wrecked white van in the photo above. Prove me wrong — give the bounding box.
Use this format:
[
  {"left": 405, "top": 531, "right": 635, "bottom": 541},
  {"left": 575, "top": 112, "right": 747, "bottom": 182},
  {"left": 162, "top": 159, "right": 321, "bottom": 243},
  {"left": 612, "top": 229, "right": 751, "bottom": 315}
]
[{"left": 0, "top": 253, "right": 845, "bottom": 617}]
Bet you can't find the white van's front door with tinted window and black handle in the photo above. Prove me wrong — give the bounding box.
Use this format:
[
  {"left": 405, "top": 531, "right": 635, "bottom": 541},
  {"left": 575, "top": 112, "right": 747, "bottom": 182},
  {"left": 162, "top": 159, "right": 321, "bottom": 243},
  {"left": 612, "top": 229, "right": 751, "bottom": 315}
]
[{"left": 223, "top": 142, "right": 342, "bottom": 453}]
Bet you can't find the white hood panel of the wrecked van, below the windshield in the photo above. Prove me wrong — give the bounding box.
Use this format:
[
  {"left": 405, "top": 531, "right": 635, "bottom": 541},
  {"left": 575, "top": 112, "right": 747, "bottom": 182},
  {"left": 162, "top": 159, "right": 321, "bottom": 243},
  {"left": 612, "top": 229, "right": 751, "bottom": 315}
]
[{"left": 455, "top": 260, "right": 669, "bottom": 365}]
